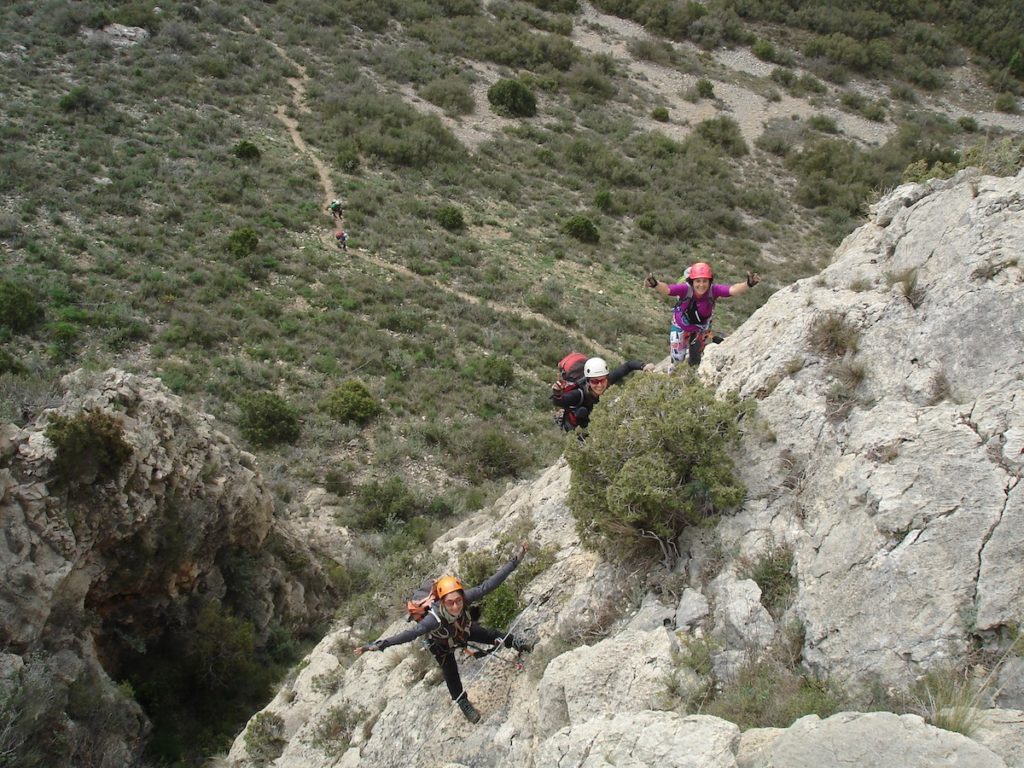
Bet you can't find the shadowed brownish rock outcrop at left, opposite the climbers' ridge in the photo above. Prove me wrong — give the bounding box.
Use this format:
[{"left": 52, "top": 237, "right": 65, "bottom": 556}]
[{"left": 0, "top": 371, "right": 324, "bottom": 765}]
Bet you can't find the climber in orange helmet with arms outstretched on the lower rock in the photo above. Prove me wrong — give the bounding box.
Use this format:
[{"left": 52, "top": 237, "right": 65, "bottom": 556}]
[{"left": 355, "top": 542, "right": 534, "bottom": 723}]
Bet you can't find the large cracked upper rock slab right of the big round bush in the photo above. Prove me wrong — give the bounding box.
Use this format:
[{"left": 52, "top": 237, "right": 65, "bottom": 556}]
[{"left": 701, "top": 171, "right": 1024, "bottom": 700}]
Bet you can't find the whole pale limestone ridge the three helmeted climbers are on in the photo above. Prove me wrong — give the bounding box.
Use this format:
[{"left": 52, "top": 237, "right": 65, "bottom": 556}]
[{"left": 227, "top": 171, "right": 1024, "bottom": 768}]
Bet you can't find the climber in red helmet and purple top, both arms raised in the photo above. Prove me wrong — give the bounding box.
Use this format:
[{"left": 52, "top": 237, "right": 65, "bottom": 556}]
[{"left": 644, "top": 261, "right": 761, "bottom": 367}]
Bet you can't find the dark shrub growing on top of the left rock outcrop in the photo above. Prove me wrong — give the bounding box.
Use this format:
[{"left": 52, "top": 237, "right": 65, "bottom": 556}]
[{"left": 45, "top": 411, "right": 132, "bottom": 485}]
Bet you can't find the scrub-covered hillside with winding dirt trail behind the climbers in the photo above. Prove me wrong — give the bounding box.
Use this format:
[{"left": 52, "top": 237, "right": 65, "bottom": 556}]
[{"left": 0, "top": 0, "right": 1024, "bottom": 765}]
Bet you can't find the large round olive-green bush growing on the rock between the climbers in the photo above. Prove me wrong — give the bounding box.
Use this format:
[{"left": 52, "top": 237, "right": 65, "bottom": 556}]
[{"left": 567, "top": 376, "right": 745, "bottom": 554}]
